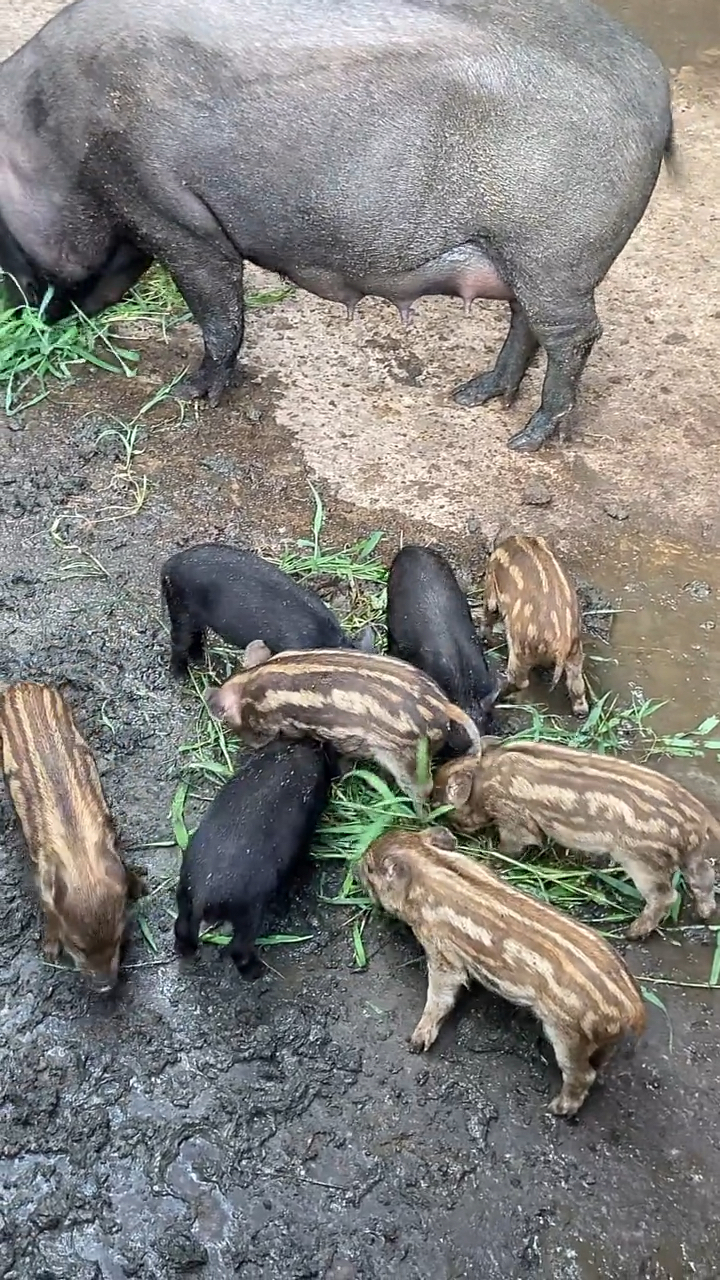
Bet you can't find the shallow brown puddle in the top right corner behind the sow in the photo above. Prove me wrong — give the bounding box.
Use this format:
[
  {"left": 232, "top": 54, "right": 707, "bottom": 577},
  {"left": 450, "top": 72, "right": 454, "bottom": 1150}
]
[{"left": 600, "top": 0, "right": 720, "bottom": 72}]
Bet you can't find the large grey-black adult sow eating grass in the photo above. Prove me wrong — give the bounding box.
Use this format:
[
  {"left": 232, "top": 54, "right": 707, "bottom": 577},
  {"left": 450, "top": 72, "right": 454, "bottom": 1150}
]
[{"left": 0, "top": 0, "right": 673, "bottom": 449}]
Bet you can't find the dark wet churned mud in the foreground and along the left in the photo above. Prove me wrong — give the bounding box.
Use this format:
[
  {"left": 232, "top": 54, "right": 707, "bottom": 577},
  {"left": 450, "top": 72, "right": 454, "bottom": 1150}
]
[{"left": 0, "top": 379, "right": 720, "bottom": 1280}]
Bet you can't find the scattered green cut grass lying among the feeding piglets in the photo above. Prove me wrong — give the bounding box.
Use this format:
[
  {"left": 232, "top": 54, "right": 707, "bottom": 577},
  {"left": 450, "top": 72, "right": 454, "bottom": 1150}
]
[{"left": 163, "top": 490, "right": 720, "bottom": 983}]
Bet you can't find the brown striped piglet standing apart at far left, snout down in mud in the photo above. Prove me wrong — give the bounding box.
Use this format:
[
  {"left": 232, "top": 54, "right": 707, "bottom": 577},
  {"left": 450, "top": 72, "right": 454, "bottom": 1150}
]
[{"left": 0, "top": 681, "right": 145, "bottom": 992}]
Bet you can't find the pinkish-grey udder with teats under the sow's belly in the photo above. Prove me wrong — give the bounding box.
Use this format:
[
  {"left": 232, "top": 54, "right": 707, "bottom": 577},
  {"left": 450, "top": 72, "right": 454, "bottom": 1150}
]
[{"left": 283, "top": 244, "right": 514, "bottom": 320}]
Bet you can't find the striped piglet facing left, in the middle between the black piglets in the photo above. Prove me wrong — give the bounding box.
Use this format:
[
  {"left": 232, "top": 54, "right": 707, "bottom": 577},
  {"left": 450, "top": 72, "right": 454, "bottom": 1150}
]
[{"left": 208, "top": 641, "right": 480, "bottom": 805}]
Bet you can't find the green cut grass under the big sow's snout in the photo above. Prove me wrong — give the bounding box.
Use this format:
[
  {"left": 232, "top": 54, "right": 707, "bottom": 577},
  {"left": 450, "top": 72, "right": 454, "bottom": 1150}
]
[{"left": 0, "top": 266, "right": 293, "bottom": 417}]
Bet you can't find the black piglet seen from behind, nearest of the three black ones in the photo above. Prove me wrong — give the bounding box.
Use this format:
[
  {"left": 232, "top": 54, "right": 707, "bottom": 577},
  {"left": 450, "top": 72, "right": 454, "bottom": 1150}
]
[{"left": 176, "top": 740, "right": 337, "bottom": 980}]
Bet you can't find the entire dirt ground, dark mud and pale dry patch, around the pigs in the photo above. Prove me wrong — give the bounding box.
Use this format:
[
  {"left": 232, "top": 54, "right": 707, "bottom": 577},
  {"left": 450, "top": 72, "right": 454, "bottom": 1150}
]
[{"left": 0, "top": 0, "right": 720, "bottom": 1280}]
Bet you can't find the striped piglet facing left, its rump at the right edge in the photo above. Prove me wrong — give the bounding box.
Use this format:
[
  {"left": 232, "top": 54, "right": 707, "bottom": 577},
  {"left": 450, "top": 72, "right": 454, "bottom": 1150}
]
[{"left": 433, "top": 737, "right": 720, "bottom": 938}]
